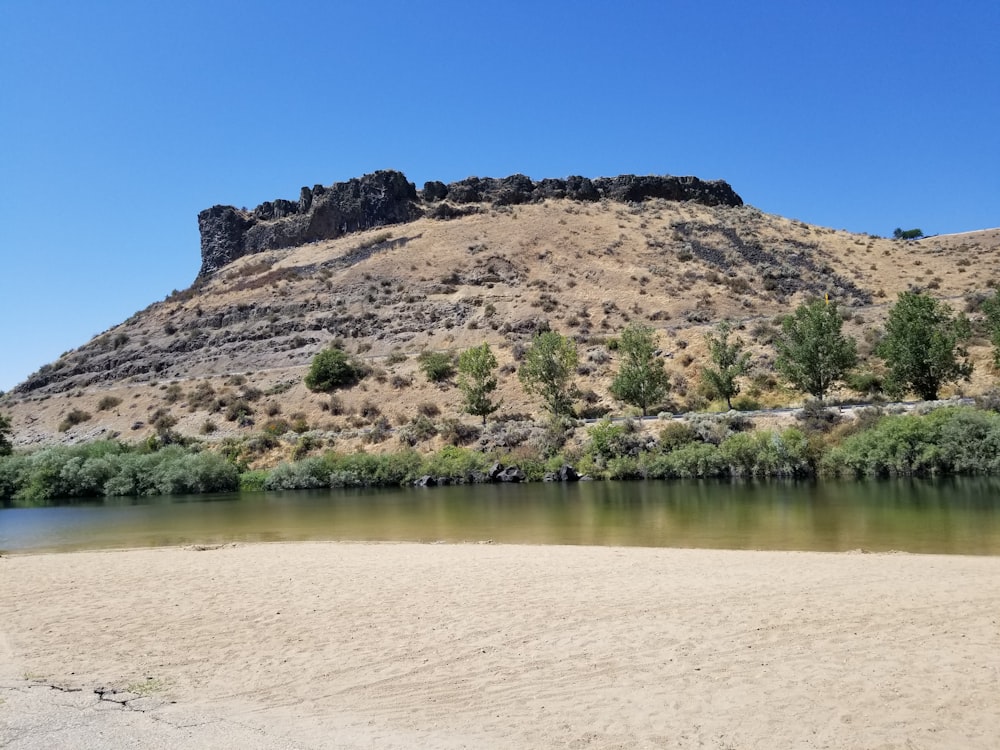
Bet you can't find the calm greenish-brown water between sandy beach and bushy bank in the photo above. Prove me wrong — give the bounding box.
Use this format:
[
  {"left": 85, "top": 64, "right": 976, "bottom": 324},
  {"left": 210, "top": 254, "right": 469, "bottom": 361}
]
[{"left": 0, "top": 478, "right": 1000, "bottom": 555}]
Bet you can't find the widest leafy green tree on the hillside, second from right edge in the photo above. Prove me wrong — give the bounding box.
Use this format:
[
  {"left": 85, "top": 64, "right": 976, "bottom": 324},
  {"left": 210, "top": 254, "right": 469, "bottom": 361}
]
[{"left": 877, "top": 292, "right": 972, "bottom": 401}]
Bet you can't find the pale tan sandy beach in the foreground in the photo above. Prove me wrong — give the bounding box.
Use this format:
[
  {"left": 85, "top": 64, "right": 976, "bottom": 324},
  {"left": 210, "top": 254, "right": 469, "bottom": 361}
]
[{"left": 0, "top": 543, "right": 1000, "bottom": 750}]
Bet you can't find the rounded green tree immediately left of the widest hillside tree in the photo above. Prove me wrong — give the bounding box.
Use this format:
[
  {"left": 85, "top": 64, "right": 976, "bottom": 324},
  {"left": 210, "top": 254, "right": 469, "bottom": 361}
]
[{"left": 774, "top": 299, "right": 858, "bottom": 401}]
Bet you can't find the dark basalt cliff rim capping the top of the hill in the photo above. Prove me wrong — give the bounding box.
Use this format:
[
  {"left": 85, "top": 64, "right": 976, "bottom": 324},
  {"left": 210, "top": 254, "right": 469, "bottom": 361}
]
[{"left": 198, "top": 171, "right": 743, "bottom": 278}]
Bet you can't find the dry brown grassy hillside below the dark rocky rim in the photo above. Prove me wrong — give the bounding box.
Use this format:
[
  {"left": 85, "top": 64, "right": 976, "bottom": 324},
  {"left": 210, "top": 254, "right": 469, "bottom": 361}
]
[{"left": 0, "top": 192, "right": 1000, "bottom": 450}]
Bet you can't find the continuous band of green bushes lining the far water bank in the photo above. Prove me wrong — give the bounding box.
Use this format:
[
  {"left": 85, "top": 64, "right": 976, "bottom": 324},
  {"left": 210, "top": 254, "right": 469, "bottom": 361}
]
[{"left": 0, "top": 406, "right": 1000, "bottom": 506}]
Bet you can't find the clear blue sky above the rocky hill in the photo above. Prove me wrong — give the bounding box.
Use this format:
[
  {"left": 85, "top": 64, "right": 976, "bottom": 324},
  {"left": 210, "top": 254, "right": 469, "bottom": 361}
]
[{"left": 0, "top": 0, "right": 1000, "bottom": 390}]
